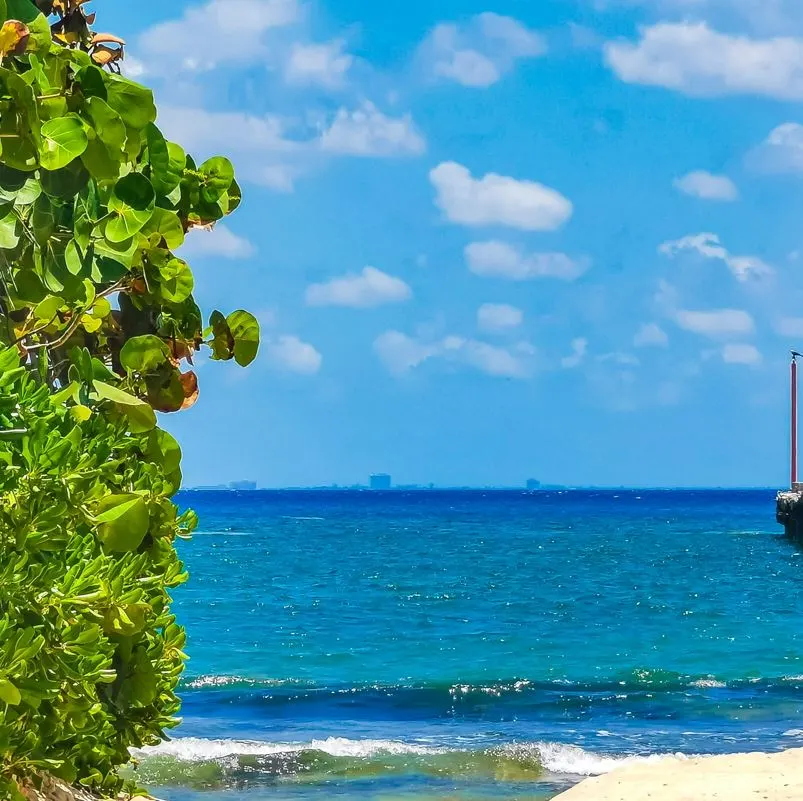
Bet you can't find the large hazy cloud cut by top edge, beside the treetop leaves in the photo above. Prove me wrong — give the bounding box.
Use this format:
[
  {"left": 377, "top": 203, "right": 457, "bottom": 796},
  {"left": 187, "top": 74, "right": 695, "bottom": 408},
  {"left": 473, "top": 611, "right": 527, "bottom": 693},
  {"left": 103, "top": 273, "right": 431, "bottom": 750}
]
[{"left": 137, "top": 0, "right": 300, "bottom": 76}]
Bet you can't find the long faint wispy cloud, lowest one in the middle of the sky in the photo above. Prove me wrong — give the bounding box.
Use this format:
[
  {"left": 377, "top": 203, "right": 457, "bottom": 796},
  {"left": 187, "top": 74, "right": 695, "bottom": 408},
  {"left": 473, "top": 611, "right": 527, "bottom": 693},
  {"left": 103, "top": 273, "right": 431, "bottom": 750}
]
[{"left": 374, "top": 331, "right": 535, "bottom": 379}]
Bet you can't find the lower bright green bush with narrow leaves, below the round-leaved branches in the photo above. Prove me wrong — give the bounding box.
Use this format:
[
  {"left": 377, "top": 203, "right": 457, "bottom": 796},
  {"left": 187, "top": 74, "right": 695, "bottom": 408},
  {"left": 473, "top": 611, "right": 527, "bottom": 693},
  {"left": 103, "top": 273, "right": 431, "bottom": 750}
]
[{"left": 0, "top": 349, "right": 195, "bottom": 798}]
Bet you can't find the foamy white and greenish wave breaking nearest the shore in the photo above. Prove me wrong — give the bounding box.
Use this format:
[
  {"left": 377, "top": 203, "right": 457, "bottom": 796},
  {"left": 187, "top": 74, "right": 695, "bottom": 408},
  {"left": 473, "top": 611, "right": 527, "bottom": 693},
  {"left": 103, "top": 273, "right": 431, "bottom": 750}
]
[{"left": 132, "top": 737, "right": 676, "bottom": 789}]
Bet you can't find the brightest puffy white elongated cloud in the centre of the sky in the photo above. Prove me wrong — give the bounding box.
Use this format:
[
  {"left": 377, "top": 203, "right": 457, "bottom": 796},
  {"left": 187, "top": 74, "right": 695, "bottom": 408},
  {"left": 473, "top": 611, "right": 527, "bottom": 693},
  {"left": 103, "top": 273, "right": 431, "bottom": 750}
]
[{"left": 429, "top": 161, "right": 573, "bottom": 231}]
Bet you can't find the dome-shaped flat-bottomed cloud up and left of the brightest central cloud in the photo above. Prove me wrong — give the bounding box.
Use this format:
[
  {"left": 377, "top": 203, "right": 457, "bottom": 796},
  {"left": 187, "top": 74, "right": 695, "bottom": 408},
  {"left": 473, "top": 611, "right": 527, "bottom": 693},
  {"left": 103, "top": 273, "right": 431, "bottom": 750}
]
[{"left": 320, "top": 102, "right": 426, "bottom": 157}]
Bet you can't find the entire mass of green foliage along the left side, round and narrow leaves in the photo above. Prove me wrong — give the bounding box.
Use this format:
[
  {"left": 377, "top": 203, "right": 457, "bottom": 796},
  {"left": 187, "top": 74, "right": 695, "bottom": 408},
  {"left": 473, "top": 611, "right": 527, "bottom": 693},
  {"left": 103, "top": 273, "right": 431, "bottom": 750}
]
[{"left": 0, "top": 0, "right": 259, "bottom": 797}]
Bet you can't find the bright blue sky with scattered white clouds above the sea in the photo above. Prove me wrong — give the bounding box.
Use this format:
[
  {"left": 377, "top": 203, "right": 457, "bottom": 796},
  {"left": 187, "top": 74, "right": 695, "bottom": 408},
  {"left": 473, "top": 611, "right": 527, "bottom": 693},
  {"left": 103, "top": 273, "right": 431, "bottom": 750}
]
[{"left": 96, "top": 0, "right": 803, "bottom": 487}]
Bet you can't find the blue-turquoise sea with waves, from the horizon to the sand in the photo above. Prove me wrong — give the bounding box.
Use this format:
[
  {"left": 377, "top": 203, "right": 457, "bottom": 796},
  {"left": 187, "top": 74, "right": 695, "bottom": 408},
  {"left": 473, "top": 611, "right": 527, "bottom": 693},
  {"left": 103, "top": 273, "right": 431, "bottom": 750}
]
[{"left": 137, "top": 490, "right": 803, "bottom": 801}]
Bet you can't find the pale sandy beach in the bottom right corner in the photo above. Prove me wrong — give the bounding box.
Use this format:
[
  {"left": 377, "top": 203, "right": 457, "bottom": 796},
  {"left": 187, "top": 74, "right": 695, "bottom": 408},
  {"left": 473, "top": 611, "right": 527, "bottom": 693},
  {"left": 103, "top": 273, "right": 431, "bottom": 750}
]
[{"left": 555, "top": 748, "right": 803, "bottom": 801}]
